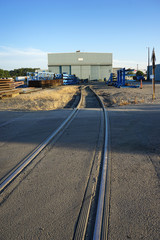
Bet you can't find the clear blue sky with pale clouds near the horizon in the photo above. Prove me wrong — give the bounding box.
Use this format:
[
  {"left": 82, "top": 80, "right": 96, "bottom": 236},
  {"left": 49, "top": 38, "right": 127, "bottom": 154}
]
[{"left": 0, "top": 0, "right": 160, "bottom": 70}]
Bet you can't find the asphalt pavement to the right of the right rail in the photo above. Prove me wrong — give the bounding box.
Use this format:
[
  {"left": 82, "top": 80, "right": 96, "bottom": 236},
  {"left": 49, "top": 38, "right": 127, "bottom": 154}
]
[{"left": 108, "top": 105, "right": 160, "bottom": 240}]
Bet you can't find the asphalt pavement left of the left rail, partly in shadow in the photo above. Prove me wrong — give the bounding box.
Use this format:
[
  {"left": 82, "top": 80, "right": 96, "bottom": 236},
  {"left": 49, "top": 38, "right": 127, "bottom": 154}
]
[{"left": 0, "top": 109, "right": 71, "bottom": 178}]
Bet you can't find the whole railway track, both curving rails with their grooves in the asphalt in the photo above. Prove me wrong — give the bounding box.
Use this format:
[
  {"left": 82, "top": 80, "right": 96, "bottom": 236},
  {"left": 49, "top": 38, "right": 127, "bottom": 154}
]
[{"left": 0, "top": 87, "right": 109, "bottom": 240}]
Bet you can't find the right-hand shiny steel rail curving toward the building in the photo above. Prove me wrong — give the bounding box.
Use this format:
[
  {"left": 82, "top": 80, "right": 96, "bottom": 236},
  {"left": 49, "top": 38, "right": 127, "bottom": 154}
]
[{"left": 91, "top": 88, "right": 108, "bottom": 240}]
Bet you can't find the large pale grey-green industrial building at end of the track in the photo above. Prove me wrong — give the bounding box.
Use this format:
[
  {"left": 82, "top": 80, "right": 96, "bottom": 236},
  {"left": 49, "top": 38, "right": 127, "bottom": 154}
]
[{"left": 48, "top": 51, "right": 112, "bottom": 80}]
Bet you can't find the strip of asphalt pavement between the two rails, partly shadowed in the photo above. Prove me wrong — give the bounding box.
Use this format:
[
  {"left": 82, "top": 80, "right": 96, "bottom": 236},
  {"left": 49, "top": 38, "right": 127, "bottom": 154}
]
[{"left": 1, "top": 108, "right": 101, "bottom": 240}]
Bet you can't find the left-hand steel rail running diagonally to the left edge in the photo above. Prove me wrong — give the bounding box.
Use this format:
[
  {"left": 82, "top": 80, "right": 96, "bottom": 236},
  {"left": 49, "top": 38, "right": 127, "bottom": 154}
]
[{"left": 0, "top": 88, "right": 82, "bottom": 193}]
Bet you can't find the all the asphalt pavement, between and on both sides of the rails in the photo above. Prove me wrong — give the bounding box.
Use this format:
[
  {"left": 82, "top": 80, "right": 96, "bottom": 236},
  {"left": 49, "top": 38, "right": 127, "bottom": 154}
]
[{"left": 0, "top": 85, "right": 160, "bottom": 240}]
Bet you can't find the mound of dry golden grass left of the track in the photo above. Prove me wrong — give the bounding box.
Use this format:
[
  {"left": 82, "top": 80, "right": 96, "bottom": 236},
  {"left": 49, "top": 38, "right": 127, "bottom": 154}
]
[{"left": 0, "top": 86, "right": 78, "bottom": 111}]
